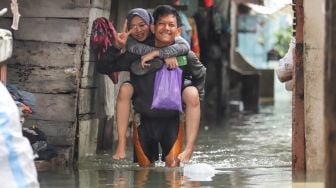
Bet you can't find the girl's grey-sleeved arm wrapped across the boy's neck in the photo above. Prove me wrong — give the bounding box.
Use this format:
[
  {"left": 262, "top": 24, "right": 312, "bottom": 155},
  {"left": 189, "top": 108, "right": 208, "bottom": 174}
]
[{"left": 126, "top": 36, "right": 190, "bottom": 58}]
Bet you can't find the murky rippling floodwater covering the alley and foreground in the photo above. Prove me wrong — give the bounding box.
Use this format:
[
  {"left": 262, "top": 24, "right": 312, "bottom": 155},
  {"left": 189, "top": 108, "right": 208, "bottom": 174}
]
[{"left": 39, "top": 80, "right": 324, "bottom": 188}]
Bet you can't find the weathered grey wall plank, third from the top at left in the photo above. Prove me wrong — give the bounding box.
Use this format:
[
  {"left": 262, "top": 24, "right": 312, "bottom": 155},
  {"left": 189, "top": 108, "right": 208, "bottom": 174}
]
[{"left": 8, "top": 40, "right": 83, "bottom": 68}]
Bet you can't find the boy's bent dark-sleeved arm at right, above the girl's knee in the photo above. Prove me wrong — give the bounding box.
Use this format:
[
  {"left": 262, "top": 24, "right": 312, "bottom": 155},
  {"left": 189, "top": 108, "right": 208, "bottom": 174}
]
[{"left": 187, "top": 51, "right": 206, "bottom": 100}]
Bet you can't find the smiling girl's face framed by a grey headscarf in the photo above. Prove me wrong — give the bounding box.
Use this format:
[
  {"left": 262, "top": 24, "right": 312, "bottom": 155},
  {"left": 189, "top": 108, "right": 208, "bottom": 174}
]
[{"left": 129, "top": 16, "right": 149, "bottom": 42}]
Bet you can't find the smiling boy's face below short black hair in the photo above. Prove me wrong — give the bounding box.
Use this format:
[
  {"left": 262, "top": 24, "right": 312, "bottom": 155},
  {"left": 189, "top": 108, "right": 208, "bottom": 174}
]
[{"left": 152, "top": 14, "right": 182, "bottom": 47}]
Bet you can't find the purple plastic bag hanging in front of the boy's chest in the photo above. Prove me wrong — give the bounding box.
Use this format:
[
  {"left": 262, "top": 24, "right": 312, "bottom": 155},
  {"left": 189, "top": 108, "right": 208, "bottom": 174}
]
[{"left": 151, "top": 65, "right": 182, "bottom": 112}]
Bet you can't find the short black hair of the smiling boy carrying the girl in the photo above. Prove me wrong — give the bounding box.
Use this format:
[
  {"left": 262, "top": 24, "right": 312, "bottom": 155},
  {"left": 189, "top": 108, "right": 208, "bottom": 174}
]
[{"left": 153, "top": 5, "right": 182, "bottom": 27}]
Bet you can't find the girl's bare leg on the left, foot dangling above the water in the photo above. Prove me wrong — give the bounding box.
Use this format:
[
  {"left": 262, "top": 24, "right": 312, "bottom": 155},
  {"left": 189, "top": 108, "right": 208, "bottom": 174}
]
[{"left": 113, "top": 83, "right": 133, "bottom": 160}]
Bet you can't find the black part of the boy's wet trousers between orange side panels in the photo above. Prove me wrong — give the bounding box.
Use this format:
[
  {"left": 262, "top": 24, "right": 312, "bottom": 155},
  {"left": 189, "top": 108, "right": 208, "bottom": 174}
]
[{"left": 134, "top": 115, "right": 180, "bottom": 163}]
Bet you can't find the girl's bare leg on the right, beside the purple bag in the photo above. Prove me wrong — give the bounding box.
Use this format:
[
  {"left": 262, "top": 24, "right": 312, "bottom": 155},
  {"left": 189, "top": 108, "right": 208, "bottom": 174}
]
[{"left": 178, "top": 86, "right": 201, "bottom": 163}]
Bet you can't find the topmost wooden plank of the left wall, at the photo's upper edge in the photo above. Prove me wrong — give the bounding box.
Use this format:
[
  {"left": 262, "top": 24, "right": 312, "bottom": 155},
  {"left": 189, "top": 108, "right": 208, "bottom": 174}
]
[{"left": 1, "top": 0, "right": 90, "bottom": 18}]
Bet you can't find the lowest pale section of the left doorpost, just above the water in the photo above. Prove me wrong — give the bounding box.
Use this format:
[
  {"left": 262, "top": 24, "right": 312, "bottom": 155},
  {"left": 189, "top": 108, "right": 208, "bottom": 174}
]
[{"left": 78, "top": 119, "right": 99, "bottom": 160}]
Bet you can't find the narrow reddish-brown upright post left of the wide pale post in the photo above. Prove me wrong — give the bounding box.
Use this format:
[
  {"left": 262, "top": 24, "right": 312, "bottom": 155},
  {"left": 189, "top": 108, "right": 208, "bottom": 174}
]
[{"left": 292, "top": 0, "right": 306, "bottom": 172}]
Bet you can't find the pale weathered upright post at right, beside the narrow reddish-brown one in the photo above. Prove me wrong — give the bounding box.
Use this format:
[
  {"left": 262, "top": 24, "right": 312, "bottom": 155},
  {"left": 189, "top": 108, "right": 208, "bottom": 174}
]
[{"left": 304, "top": 0, "right": 325, "bottom": 171}]
